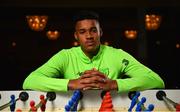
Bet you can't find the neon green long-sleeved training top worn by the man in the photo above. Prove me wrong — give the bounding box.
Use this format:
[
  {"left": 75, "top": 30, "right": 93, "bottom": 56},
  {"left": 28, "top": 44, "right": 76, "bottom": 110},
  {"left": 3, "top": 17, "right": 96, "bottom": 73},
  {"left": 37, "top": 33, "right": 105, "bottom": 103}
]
[{"left": 23, "top": 45, "right": 164, "bottom": 92}]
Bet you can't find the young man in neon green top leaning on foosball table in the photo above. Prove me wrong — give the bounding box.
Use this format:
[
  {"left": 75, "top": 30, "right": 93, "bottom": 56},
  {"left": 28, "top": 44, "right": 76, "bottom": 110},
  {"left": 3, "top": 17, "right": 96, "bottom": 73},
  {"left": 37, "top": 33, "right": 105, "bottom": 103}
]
[{"left": 23, "top": 11, "right": 164, "bottom": 92}]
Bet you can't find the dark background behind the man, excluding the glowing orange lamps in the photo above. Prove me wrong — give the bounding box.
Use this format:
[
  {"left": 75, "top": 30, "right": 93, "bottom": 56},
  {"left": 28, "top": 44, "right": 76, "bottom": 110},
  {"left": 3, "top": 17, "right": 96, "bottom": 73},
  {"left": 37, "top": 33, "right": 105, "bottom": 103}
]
[{"left": 0, "top": 0, "right": 180, "bottom": 90}]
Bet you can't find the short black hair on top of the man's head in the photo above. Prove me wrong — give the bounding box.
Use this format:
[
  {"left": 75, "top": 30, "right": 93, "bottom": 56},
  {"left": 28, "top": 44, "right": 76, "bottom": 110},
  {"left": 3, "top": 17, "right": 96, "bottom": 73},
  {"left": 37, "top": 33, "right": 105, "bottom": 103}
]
[{"left": 73, "top": 10, "right": 99, "bottom": 24}]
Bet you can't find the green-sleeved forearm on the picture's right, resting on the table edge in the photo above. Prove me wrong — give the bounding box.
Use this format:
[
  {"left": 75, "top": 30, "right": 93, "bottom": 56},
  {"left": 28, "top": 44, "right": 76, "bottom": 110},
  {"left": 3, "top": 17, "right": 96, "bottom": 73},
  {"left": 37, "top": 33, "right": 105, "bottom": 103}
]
[{"left": 116, "top": 73, "right": 165, "bottom": 92}]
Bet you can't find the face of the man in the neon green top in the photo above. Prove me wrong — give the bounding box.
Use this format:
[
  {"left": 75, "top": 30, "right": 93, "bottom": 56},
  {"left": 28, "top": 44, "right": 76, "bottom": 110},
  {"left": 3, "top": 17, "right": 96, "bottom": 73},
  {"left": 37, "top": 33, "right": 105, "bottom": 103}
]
[{"left": 74, "top": 19, "right": 101, "bottom": 53}]
